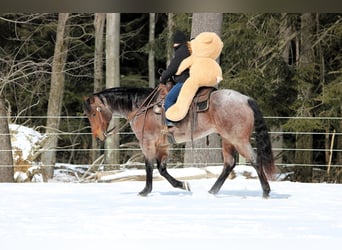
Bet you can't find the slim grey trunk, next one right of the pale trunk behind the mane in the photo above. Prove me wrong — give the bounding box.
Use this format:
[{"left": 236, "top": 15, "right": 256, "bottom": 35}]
[{"left": 148, "top": 13, "right": 156, "bottom": 88}]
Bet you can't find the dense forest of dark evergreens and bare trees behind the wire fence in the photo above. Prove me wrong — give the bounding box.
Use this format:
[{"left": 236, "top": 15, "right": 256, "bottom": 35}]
[{"left": 0, "top": 13, "right": 342, "bottom": 181}]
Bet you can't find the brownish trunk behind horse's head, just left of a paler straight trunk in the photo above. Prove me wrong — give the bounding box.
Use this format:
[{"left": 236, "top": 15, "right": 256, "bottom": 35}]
[{"left": 90, "top": 13, "right": 106, "bottom": 162}]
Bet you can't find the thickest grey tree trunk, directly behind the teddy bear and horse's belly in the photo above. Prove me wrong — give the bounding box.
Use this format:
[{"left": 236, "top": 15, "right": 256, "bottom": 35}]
[{"left": 184, "top": 13, "right": 223, "bottom": 166}]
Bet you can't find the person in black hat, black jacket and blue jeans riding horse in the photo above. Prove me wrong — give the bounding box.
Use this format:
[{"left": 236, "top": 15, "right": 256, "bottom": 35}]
[{"left": 159, "top": 30, "right": 190, "bottom": 127}]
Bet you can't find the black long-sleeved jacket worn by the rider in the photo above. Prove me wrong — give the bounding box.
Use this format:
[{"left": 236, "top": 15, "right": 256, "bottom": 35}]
[{"left": 160, "top": 43, "right": 190, "bottom": 83}]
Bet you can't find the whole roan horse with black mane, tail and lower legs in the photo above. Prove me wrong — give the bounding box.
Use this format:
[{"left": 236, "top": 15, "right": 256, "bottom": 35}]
[{"left": 83, "top": 87, "right": 274, "bottom": 198}]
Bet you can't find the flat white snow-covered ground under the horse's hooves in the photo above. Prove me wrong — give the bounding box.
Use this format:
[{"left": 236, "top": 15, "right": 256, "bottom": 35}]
[{"left": 0, "top": 165, "right": 342, "bottom": 250}]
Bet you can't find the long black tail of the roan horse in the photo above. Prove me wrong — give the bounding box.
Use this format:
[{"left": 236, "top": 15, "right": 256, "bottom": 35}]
[{"left": 248, "top": 99, "right": 275, "bottom": 178}]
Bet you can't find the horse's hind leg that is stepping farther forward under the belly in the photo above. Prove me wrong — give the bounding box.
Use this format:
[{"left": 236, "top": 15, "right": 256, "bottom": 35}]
[{"left": 209, "top": 142, "right": 235, "bottom": 194}]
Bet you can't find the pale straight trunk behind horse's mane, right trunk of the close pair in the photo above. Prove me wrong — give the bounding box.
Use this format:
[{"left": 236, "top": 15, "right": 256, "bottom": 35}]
[{"left": 104, "top": 13, "right": 120, "bottom": 170}]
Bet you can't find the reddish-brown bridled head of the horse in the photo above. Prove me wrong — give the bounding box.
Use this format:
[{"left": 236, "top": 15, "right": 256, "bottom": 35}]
[{"left": 83, "top": 95, "right": 112, "bottom": 141}]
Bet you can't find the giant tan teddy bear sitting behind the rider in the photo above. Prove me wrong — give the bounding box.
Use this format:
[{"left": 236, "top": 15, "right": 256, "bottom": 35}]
[{"left": 166, "top": 32, "right": 223, "bottom": 121}]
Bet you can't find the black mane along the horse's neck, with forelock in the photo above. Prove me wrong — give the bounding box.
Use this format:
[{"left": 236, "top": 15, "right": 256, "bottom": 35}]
[{"left": 84, "top": 87, "right": 153, "bottom": 114}]
